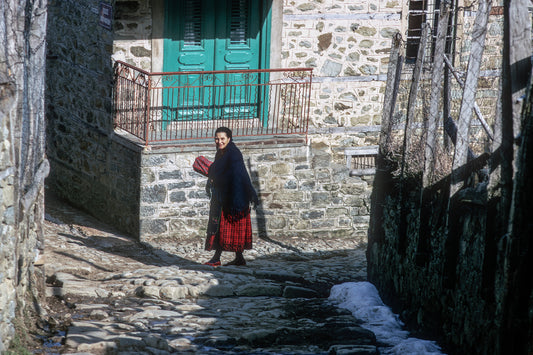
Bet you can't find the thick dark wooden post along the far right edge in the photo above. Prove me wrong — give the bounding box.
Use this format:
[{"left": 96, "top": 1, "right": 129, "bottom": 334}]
[{"left": 489, "top": 0, "right": 532, "bottom": 354}]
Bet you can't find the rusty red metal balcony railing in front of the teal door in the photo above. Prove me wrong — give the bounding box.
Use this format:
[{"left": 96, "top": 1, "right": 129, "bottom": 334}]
[{"left": 114, "top": 61, "right": 312, "bottom": 145}]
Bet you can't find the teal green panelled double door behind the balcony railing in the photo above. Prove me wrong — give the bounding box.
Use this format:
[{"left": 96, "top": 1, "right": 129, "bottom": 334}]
[{"left": 163, "top": 0, "right": 270, "bottom": 125}]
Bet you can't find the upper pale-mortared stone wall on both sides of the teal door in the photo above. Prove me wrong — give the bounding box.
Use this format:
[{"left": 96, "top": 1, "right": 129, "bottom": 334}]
[{"left": 113, "top": 0, "right": 401, "bottom": 127}]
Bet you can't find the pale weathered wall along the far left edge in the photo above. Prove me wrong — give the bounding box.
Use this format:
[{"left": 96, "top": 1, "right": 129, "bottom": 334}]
[{"left": 0, "top": 0, "right": 48, "bottom": 353}]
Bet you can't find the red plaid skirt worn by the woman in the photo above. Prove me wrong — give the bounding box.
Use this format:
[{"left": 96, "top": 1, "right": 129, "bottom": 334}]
[{"left": 205, "top": 211, "right": 252, "bottom": 253}]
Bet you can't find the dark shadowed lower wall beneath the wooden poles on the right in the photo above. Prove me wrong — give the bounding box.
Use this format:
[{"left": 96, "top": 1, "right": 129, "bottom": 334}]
[{"left": 367, "top": 147, "right": 533, "bottom": 355}]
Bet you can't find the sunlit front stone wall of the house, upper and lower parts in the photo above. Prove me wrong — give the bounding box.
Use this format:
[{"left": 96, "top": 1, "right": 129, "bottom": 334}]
[{"left": 108, "top": 0, "right": 394, "bottom": 243}]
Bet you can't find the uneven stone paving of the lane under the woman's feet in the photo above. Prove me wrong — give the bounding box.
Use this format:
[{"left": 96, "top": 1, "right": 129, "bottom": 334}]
[{"left": 40, "top": 196, "right": 377, "bottom": 354}]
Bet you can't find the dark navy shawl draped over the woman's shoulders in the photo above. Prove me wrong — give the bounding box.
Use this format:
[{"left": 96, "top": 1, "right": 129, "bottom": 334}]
[{"left": 207, "top": 140, "right": 258, "bottom": 220}]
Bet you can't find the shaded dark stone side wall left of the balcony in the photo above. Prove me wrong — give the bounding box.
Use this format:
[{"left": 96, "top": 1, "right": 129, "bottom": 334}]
[{"left": 46, "top": 0, "right": 140, "bottom": 238}]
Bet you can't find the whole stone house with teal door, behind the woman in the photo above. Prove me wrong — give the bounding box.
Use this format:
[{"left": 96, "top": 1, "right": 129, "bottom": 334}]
[{"left": 43, "top": 0, "right": 498, "bottom": 245}]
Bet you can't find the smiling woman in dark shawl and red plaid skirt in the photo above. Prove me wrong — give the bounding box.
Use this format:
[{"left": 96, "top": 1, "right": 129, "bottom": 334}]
[{"left": 205, "top": 127, "right": 258, "bottom": 266}]
